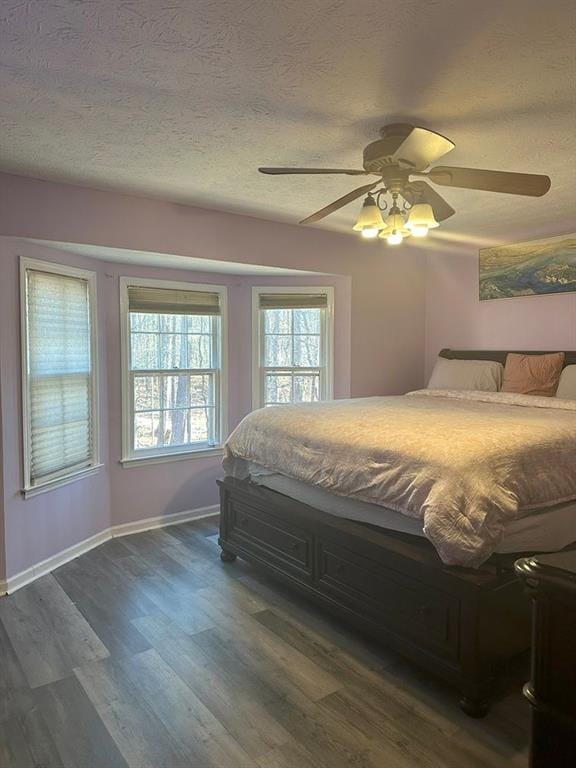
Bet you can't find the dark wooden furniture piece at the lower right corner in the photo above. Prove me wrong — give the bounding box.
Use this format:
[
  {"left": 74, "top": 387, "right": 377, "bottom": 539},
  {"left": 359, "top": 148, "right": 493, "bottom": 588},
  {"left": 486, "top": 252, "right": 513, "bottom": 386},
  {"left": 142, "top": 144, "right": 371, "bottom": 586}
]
[{"left": 515, "top": 550, "right": 576, "bottom": 768}]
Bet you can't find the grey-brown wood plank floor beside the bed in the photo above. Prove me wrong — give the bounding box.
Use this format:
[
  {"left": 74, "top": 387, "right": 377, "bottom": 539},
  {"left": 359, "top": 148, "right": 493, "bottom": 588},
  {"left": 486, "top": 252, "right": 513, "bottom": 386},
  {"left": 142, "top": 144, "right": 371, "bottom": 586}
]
[{"left": 0, "top": 518, "right": 528, "bottom": 768}]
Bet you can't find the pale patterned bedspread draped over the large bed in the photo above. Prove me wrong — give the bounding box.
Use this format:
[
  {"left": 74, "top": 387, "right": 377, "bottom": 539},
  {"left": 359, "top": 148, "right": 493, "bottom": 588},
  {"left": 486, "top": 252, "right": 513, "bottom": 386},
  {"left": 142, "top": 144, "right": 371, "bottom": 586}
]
[{"left": 224, "top": 390, "right": 576, "bottom": 567}]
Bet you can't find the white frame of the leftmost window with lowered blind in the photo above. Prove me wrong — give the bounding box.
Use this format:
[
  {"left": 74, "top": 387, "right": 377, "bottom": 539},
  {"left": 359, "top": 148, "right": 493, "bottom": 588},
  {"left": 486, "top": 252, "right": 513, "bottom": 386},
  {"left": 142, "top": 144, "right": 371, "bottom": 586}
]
[{"left": 20, "top": 256, "right": 103, "bottom": 498}]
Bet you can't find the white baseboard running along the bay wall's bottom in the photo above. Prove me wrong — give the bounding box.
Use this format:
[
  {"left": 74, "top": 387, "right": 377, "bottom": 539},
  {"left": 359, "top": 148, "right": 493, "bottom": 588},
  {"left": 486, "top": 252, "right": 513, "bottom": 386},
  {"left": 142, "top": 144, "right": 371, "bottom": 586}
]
[{"left": 0, "top": 504, "right": 220, "bottom": 596}]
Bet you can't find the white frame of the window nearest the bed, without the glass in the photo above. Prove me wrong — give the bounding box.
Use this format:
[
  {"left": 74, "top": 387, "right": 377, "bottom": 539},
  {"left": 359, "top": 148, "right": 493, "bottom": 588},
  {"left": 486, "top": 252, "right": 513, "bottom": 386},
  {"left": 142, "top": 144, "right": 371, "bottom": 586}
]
[{"left": 252, "top": 285, "right": 334, "bottom": 410}]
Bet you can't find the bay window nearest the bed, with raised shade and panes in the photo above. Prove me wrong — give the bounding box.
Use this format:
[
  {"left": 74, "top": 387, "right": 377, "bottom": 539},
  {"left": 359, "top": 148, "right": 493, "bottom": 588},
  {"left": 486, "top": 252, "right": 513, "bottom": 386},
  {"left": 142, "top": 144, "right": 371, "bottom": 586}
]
[{"left": 253, "top": 288, "right": 333, "bottom": 408}]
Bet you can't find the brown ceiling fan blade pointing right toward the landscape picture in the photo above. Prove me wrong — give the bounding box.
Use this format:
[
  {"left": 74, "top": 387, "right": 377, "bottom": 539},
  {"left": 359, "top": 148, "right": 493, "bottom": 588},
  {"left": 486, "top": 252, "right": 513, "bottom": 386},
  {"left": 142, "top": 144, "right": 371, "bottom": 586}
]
[{"left": 426, "top": 165, "right": 550, "bottom": 197}]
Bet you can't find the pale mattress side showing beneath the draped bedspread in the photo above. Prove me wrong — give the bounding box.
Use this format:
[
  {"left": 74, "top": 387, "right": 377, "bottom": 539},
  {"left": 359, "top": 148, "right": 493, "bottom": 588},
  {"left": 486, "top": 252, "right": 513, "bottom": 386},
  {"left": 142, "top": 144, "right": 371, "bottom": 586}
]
[{"left": 245, "top": 464, "right": 576, "bottom": 554}]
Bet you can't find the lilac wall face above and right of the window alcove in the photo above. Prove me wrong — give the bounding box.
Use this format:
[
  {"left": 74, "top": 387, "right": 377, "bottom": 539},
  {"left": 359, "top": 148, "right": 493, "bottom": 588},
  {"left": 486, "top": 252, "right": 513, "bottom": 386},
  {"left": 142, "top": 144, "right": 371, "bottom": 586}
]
[{"left": 0, "top": 174, "right": 425, "bottom": 395}]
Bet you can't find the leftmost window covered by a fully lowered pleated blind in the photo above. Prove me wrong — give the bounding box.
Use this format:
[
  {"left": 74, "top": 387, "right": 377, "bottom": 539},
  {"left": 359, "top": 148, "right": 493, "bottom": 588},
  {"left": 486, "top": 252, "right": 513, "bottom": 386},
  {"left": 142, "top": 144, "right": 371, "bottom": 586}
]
[{"left": 20, "top": 259, "right": 99, "bottom": 493}]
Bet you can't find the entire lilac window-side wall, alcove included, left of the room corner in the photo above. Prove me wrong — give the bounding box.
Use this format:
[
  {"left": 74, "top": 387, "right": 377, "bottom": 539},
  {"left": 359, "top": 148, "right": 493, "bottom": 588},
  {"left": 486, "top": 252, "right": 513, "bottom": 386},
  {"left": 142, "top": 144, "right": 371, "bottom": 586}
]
[{"left": 0, "top": 174, "right": 424, "bottom": 579}]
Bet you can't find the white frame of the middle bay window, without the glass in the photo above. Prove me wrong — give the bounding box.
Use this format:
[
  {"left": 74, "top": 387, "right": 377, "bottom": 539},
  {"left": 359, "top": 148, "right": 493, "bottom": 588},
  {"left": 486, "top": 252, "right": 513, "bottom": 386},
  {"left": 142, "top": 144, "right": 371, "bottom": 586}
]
[{"left": 120, "top": 276, "right": 228, "bottom": 467}]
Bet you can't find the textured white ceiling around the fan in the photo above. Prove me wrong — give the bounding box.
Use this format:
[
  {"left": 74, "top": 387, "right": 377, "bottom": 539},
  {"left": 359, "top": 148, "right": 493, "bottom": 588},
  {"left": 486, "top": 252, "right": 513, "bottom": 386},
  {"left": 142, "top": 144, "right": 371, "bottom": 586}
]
[{"left": 0, "top": 0, "right": 576, "bottom": 240}]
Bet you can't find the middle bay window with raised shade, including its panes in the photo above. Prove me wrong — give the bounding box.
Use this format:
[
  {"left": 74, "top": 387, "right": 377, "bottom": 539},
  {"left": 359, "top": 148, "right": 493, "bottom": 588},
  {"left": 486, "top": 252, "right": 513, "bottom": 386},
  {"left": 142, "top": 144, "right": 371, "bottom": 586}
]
[{"left": 122, "top": 278, "right": 225, "bottom": 461}]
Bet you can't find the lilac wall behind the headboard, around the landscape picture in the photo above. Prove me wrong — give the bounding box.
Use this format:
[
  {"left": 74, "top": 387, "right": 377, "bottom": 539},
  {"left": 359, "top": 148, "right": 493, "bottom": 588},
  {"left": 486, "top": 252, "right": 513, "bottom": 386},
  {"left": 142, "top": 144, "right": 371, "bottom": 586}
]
[{"left": 425, "top": 249, "right": 576, "bottom": 375}]
